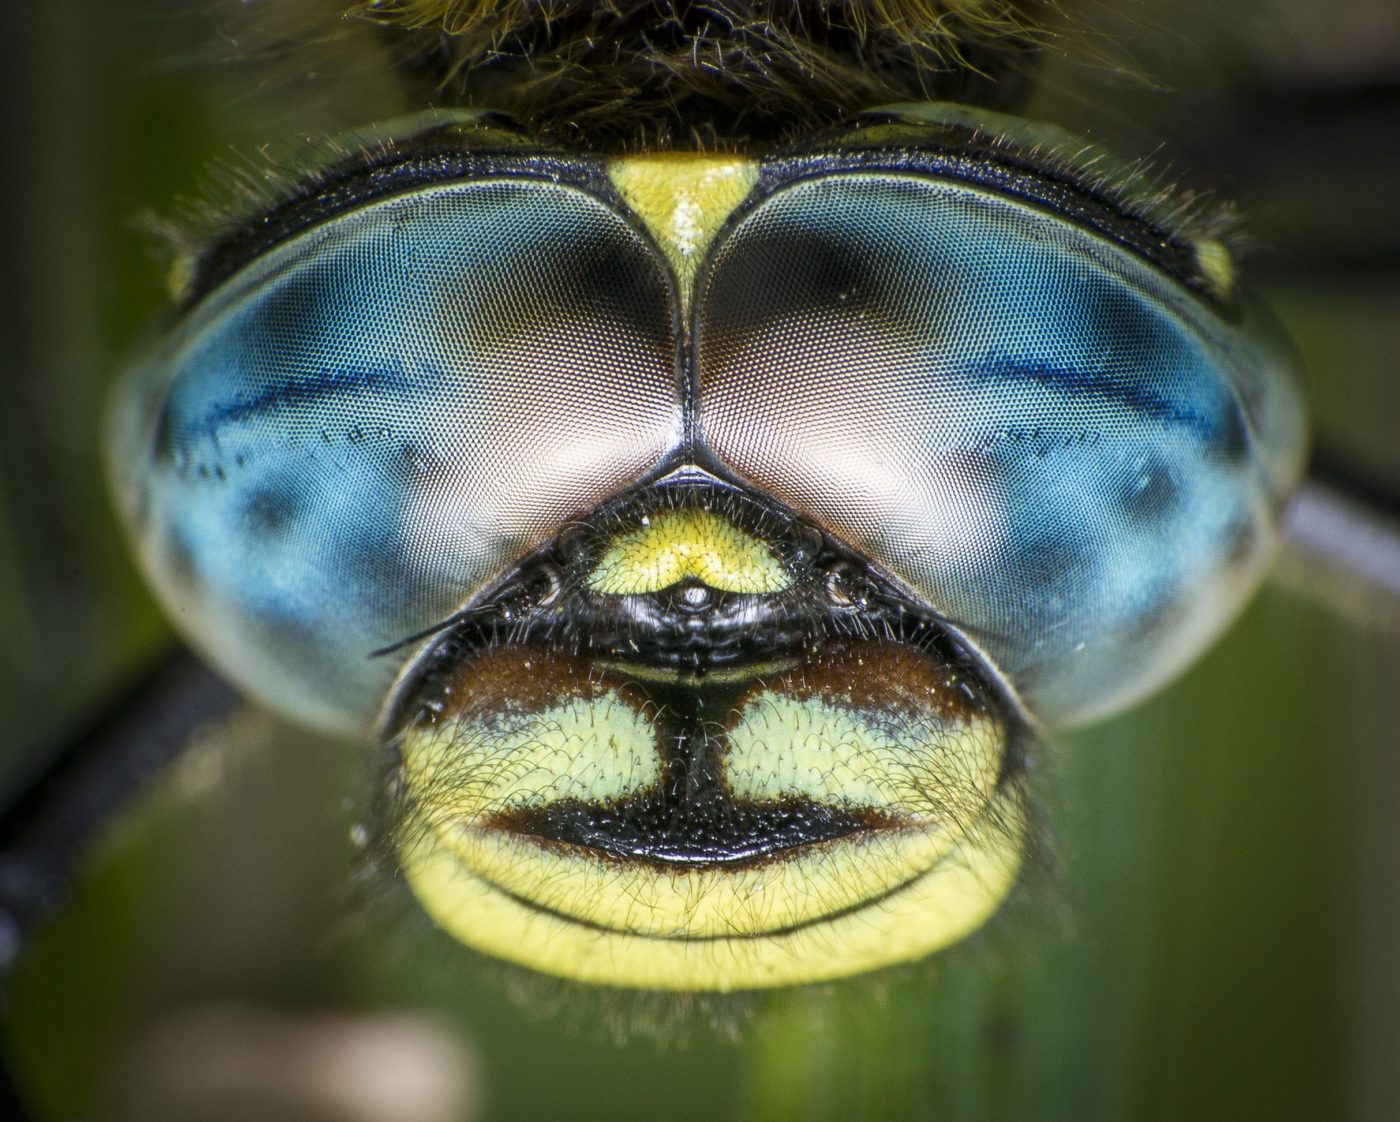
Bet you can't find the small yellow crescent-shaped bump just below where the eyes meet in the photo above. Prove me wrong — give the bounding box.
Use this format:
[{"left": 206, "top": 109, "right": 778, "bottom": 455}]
[{"left": 588, "top": 510, "right": 792, "bottom": 595}]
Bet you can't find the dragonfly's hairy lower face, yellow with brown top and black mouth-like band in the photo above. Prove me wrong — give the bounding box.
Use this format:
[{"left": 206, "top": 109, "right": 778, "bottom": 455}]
[{"left": 399, "top": 642, "right": 1026, "bottom": 990}]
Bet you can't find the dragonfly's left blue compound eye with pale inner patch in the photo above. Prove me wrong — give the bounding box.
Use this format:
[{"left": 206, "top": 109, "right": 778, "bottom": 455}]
[{"left": 113, "top": 178, "right": 680, "bottom": 733}]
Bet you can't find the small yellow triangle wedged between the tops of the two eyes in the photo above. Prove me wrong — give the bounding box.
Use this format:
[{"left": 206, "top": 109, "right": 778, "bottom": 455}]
[{"left": 608, "top": 153, "right": 759, "bottom": 307}]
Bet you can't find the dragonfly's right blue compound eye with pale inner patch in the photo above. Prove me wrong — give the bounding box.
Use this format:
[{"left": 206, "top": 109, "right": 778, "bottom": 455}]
[{"left": 696, "top": 172, "right": 1302, "bottom": 724}]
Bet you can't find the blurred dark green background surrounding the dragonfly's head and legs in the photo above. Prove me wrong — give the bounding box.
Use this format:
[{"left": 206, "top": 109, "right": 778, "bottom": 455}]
[{"left": 0, "top": 0, "right": 1400, "bottom": 1122}]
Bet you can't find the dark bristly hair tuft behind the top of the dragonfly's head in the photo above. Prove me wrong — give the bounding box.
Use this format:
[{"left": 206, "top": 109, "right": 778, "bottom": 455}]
[{"left": 349, "top": 0, "right": 1053, "bottom": 147}]
